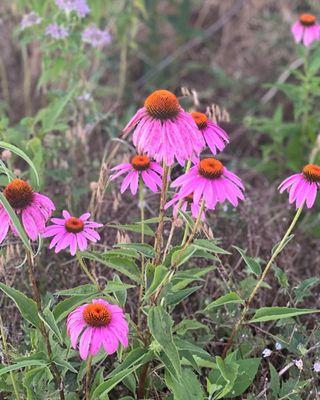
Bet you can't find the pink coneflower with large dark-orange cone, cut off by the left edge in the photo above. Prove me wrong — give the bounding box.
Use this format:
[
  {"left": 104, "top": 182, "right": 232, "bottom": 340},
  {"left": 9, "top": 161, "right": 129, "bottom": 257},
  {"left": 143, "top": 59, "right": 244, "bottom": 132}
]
[{"left": 0, "top": 179, "right": 55, "bottom": 243}]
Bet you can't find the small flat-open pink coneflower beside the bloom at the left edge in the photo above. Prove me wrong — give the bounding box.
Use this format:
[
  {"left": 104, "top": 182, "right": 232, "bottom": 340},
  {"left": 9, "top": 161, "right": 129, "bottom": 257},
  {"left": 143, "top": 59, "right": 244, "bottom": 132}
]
[{"left": 43, "top": 210, "right": 103, "bottom": 256}]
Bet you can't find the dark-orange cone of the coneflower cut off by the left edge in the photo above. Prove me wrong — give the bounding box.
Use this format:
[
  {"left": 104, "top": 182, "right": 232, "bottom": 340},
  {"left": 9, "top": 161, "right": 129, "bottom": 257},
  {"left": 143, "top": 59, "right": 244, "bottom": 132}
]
[{"left": 3, "top": 179, "right": 33, "bottom": 209}]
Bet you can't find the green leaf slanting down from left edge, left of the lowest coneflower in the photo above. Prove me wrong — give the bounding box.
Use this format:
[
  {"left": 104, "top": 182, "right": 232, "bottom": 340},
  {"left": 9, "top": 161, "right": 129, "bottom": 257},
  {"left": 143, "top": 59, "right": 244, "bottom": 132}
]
[{"left": 0, "top": 283, "right": 41, "bottom": 328}]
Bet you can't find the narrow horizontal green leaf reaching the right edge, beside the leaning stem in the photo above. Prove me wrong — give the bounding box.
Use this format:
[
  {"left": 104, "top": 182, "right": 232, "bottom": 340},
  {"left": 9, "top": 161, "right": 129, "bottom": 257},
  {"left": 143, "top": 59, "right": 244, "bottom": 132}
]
[{"left": 249, "top": 307, "right": 320, "bottom": 323}]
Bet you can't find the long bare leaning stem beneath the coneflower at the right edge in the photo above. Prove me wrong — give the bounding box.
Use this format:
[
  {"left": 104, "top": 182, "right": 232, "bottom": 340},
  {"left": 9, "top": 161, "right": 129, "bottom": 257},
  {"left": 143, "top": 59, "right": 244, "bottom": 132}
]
[{"left": 222, "top": 205, "right": 303, "bottom": 358}]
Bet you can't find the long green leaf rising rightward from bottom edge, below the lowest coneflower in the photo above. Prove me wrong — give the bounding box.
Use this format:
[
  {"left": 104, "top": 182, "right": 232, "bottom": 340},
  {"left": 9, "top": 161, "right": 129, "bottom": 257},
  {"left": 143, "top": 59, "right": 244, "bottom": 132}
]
[{"left": 92, "top": 348, "right": 154, "bottom": 400}]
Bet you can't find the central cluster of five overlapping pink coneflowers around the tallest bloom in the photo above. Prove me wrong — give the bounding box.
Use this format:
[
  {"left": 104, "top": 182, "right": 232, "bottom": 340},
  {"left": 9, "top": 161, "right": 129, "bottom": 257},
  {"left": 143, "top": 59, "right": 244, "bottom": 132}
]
[{"left": 110, "top": 89, "right": 244, "bottom": 219}]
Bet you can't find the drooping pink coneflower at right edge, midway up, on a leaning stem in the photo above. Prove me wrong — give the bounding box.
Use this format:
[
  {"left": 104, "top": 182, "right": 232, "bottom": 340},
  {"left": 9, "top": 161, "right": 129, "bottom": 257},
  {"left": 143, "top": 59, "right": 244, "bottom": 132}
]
[{"left": 278, "top": 164, "right": 320, "bottom": 208}]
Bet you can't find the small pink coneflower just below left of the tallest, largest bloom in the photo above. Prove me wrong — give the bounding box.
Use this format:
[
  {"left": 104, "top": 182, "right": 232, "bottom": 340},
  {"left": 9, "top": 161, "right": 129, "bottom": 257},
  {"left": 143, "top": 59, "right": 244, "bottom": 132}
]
[{"left": 110, "top": 154, "right": 163, "bottom": 195}]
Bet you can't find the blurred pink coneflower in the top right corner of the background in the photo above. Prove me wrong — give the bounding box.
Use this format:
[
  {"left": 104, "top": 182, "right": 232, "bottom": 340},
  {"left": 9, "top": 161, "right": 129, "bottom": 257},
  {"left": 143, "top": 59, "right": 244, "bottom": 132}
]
[{"left": 291, "top": 13, "right": 320, "bottom": 46}]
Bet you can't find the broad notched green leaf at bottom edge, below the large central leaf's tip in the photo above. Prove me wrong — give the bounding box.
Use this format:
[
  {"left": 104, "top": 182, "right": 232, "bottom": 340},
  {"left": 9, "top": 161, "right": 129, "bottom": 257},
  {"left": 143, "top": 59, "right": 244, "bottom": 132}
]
[{"left": 165, "top": 368, "right": 205, "bottom": 400}]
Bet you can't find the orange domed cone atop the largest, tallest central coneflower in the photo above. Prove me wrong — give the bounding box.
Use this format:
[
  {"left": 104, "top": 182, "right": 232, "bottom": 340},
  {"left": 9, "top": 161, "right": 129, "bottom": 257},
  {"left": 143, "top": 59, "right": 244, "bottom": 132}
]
[{"left": 144, "top": 89, "right": 180, "bottom": 120}]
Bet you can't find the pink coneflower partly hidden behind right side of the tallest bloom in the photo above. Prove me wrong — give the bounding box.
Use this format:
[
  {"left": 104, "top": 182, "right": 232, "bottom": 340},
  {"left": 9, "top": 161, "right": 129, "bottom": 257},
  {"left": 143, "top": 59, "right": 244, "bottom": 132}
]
[{"left": 191, "top": 111, "right": 229, "bottom": 155}]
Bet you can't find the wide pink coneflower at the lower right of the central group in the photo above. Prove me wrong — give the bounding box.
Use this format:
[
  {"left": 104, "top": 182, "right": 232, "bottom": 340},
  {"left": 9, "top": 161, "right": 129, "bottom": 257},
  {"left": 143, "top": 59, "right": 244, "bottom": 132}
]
[{"left": 171, "top": 157, "right": 244, "bottom": 209}]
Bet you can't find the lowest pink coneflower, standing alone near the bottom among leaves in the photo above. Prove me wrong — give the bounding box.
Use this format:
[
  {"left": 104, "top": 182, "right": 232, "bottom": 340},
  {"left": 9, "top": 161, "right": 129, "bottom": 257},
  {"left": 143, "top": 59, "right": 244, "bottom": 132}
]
[{"left": 67, "top": 299, "right": 129, "bottom": 360}]
